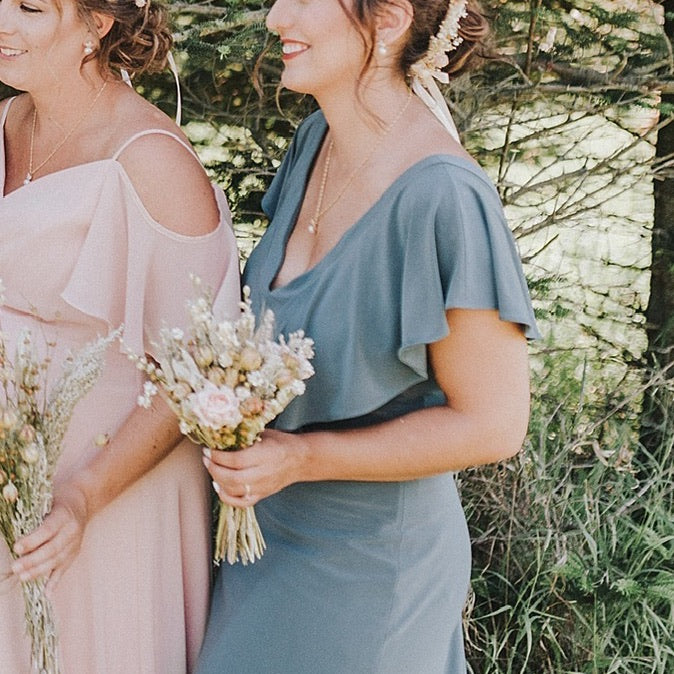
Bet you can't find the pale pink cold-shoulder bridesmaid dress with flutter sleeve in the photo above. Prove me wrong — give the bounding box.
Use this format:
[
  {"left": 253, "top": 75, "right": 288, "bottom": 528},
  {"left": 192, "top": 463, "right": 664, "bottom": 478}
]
[{"left": 0, "top": 101, "right": 239, "bottom": 674}]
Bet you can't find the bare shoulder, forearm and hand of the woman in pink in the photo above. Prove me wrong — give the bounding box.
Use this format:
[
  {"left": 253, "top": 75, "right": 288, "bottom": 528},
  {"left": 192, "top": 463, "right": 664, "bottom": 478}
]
[{"left": 12, "top": 129, "right": 226, "bottom": 588}]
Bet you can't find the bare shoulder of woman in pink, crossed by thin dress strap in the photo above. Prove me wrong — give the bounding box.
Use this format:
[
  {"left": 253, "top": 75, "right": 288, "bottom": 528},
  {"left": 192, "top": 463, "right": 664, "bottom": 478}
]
[{"left": 108, "top": 90, "right": 220, "bottom": 236}]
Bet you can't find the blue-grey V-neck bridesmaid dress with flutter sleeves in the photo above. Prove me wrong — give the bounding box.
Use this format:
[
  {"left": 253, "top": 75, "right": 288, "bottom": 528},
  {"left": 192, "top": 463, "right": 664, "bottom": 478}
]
[{"left": 197, "top": 112, "right": 537, "bottom": 674}]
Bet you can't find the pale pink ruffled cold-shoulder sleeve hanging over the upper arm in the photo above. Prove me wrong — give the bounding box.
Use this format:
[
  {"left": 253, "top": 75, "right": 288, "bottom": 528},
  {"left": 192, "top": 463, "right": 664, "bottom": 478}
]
[{"left": 61, "top": 167, "right": 239, "bottom": 354}]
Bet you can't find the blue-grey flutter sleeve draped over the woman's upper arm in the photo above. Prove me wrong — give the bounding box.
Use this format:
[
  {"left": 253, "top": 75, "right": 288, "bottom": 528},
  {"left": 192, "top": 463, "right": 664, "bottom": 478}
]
[{"left": 398, "top": 158, "right": 540, "bottom": 378}]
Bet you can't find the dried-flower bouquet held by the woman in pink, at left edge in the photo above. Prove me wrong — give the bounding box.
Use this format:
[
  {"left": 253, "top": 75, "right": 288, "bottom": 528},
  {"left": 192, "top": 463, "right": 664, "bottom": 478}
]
[{"left": 0, "top": 282, "right": 118, "bottom": 674}]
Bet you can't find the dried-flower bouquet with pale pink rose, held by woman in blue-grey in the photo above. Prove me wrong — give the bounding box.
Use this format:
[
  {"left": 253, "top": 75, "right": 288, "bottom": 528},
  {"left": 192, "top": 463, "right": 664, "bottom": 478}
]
[{"left": 129, "top": 278, "right": 314, "bottom": 564}]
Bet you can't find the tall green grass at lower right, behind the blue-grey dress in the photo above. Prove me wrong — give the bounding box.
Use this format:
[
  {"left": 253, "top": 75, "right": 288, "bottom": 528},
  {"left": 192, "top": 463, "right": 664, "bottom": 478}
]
[{"left": 460, "top": 354, "right": 674, "bottom": 674}]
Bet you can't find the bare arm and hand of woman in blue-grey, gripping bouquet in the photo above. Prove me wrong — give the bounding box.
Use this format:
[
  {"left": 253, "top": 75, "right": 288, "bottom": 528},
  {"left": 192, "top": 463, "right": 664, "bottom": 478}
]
[{"left": 204, "top": 309, "right": 529, "bottom": 506}]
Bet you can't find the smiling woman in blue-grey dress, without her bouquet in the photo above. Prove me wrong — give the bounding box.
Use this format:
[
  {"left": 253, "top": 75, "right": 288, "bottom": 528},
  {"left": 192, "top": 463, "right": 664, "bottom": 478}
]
[{"left": 197, "top": 0, "right": 537, "bottom": 674}]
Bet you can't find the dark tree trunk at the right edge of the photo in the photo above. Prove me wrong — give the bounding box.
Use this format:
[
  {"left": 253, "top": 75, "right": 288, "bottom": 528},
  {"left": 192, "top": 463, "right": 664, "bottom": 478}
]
[{"left": 641, "top": 0, "right": 674, "bottom": 458}]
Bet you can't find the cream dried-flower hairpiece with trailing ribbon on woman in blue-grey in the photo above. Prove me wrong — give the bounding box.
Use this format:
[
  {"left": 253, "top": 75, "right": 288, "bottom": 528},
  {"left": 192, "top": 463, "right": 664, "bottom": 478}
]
[{"left": 409, "top": 0, "right": 468, "bottom": 142}]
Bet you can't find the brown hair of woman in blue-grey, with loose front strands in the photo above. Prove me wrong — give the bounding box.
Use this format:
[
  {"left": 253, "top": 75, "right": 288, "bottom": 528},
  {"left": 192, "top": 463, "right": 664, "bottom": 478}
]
[{"left": 339, "top": 0, "right": 489, "bottom": 78}]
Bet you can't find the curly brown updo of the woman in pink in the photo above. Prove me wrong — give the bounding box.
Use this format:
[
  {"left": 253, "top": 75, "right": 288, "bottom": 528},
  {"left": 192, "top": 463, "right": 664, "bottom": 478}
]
[{"left": 76, "top": 0, "right": 173, "bottom": 75}]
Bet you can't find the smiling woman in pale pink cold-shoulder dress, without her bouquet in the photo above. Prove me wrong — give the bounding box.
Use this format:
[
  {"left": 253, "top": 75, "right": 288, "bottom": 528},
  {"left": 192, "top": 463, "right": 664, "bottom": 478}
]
[{"left": 0, "top": 0, "right": 239, "bottom": 674}]
